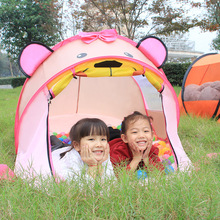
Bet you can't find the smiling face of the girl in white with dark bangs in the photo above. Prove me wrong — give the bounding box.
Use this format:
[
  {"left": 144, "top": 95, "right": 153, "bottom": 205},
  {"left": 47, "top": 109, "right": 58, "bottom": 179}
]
[{"left": 76, "top": 135, "right": 108, "bottom": 161}]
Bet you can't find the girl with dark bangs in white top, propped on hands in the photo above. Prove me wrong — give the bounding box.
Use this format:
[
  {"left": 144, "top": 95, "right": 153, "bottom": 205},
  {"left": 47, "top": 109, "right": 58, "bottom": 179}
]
[{"left": 52, "top": 118, "right": 114, "bottom": 180}]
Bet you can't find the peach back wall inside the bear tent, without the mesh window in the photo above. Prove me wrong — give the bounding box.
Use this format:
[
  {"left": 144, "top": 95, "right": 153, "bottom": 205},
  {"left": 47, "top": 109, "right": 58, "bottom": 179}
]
[{"left": 49, "top": 77, "right": 146, "bottom": 132}]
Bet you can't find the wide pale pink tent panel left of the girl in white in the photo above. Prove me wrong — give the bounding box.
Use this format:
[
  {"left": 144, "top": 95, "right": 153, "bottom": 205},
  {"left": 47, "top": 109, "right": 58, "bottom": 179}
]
[{"left": 15, "top": 91, "right": 51, "bottom": 176}]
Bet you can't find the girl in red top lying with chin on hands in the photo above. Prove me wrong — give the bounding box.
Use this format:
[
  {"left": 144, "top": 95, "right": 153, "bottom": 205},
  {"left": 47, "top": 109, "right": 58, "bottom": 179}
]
[{"left": 109, "top": 111, "right": 164, "bottom": 175}]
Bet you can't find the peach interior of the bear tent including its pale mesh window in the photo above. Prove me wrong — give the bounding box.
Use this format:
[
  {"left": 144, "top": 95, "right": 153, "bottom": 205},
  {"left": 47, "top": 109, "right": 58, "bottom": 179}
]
[{"left": 49, "top": 75, "right": 167, "bottom": 139}]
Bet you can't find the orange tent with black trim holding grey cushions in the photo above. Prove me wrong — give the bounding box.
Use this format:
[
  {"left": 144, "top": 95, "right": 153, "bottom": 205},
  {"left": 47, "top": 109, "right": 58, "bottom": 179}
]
[{"left": 178, "top": 53, "right": 220, "bottom": 122}]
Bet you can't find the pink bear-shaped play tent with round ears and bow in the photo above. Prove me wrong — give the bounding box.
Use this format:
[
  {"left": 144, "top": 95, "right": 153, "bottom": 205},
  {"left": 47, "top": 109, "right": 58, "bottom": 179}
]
[{"left": 15, "top": 30, "right": 191, "bottom": 180}]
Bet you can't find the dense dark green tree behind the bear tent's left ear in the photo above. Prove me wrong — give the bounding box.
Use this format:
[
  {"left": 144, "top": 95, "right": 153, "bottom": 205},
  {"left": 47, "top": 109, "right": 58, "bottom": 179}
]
[{"left": 0, "top": 0, "right": 61, "bottom": 61}]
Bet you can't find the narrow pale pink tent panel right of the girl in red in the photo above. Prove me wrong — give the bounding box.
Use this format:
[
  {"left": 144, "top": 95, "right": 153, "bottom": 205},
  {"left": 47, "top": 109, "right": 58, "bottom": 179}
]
[{"left": 163, "top": 86, "right": 191, "bottom": 170}]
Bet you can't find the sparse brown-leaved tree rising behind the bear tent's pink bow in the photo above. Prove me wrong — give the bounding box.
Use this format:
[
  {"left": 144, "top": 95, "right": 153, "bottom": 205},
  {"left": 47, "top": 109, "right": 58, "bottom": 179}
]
[{"left": 71, "top": 0, "right": 202, "bottom": 39}]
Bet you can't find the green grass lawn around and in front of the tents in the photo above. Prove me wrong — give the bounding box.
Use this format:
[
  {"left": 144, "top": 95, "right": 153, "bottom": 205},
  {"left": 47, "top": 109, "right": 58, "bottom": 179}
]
[{"left": 0, "top": 88, "right": 220, "bottom": 220}]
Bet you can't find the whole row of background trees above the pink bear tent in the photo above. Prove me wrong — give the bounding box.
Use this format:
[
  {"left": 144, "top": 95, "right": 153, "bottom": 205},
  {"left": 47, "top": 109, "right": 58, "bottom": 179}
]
[{"left": 0, "top": 0, "right": 220, "bottom": 63}]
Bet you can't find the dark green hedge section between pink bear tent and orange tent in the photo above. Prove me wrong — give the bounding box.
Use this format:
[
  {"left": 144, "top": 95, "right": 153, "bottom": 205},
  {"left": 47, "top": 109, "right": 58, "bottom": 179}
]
[{"left": 163, "top": 63, "right": 191, "bottom": 86}]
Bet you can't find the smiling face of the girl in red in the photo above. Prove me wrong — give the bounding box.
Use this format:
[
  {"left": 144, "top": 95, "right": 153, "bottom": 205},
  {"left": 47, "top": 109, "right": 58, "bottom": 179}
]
[{"left": 121, "top": 119, "right": 153, "bottom": 150}]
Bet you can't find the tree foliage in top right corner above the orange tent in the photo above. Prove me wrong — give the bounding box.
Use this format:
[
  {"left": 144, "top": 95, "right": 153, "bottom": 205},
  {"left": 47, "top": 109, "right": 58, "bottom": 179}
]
[{"left": 192, "top": 0, "right": 220, "bottom": 50}]
